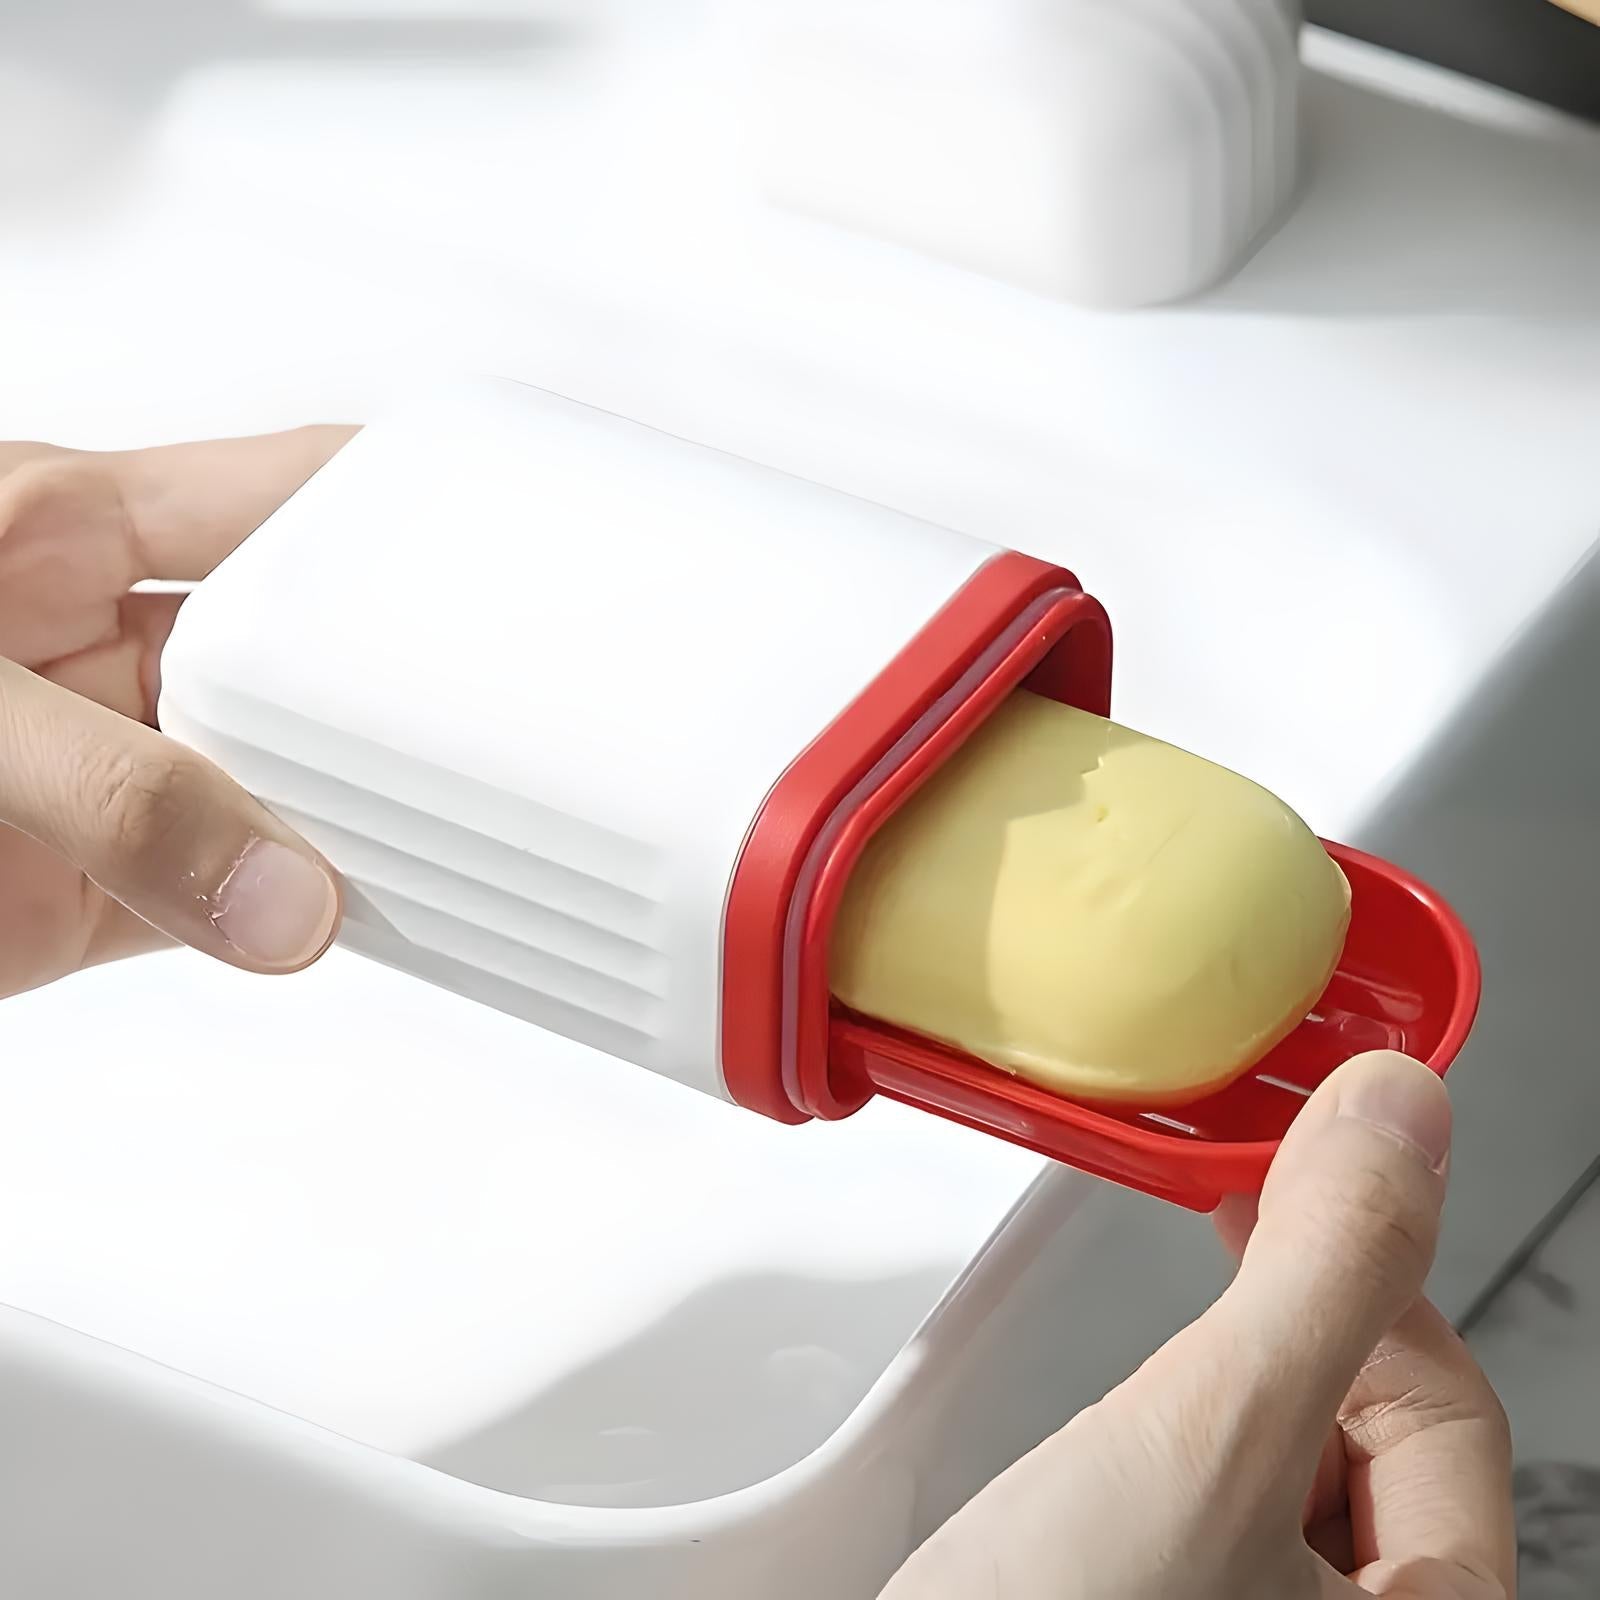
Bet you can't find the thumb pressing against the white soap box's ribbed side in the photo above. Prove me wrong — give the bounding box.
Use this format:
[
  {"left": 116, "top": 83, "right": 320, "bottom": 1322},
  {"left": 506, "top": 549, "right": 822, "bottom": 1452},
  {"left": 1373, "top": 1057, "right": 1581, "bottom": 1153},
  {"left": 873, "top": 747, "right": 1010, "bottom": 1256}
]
[{"left": 0, "top": 661, "right": 339, "bottom": 973}]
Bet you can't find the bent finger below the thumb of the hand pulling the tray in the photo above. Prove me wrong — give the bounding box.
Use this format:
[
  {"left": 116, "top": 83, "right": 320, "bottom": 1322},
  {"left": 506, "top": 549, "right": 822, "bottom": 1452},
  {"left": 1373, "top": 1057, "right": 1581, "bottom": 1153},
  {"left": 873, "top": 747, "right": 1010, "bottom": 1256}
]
[{"left": 1341, "top": 1301, "right": 1517, "bottom": 1594}]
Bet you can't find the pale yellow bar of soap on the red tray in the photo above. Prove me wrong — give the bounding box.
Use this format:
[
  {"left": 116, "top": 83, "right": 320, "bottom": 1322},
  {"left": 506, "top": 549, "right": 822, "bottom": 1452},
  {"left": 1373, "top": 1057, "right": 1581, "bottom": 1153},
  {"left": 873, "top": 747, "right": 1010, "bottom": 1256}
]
[{"left": 830, "top": 691, "right": 1350, "bottom": 1104}]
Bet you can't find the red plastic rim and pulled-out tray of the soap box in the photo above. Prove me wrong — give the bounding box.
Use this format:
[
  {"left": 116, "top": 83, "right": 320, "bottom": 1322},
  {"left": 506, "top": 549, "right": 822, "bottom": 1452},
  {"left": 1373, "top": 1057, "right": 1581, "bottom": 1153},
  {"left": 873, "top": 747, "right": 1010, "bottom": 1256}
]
[{"left": 722, "top": 552, "right": 1480, "bottom": 1211}]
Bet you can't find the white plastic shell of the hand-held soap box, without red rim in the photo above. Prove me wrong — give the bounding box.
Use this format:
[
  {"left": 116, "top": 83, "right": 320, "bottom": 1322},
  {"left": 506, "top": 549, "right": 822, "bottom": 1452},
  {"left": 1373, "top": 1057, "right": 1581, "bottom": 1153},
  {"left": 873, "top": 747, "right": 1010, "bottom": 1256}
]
[{"left": 162, "top": 381, "right": 994, "bottom": 1094}]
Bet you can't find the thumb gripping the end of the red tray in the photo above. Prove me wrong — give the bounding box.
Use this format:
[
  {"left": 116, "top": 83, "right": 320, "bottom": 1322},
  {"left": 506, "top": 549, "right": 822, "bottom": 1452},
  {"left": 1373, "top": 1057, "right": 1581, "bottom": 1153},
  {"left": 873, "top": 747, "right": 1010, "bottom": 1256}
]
[{"left": 1205, "top": 1051, "right": 1451, "bottom": 1483}]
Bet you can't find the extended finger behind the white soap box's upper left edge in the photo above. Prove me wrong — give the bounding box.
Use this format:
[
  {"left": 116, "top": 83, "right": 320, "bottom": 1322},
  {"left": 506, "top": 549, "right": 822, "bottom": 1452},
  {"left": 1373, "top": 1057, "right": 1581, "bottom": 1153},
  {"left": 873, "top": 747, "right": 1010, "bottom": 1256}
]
[{"left": 106, "top": 426, "right": 358, "bottom": 582}]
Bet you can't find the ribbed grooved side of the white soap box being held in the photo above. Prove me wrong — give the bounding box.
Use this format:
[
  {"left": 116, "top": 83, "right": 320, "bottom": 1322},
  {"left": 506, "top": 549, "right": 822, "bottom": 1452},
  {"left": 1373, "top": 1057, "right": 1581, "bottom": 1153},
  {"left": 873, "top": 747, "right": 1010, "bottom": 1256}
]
[{"left": 168, "top": 688, "right": 670, "bottom": 1058}]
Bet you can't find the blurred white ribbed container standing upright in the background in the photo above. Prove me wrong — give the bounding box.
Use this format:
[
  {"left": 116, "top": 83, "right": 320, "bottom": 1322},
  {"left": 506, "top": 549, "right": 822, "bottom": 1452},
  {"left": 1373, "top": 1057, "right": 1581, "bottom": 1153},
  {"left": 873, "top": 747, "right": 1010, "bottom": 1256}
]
[{"left": 749, "top": 0, "right": 1299, "bottom": 307}]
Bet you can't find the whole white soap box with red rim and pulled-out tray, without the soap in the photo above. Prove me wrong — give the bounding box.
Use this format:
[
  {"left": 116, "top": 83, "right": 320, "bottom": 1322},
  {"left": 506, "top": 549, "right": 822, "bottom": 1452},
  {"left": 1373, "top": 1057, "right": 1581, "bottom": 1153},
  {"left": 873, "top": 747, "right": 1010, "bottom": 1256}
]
[{"left": 162, "top": 382, "right": 1478, "bottom": 1208}]
